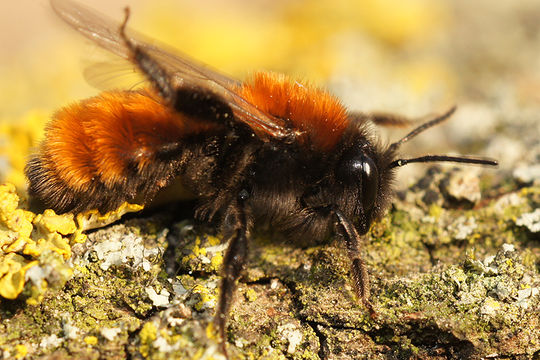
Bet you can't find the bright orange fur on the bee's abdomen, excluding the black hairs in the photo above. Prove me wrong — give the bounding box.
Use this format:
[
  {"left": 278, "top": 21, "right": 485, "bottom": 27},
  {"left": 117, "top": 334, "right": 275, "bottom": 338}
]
[{"left": 42, "top": 91, "right": 219, "bottom": 191}]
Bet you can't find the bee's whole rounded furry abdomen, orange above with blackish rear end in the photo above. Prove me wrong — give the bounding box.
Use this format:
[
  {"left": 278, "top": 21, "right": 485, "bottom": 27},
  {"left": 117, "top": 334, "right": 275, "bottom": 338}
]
[{"left": 25, "top": 91, "right": 204, "bottom": 213}]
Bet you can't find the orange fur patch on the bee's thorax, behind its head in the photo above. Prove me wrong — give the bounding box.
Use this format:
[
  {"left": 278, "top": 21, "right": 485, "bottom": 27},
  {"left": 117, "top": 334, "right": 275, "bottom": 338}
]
[{"left": 238, "top": 72, "right": 349, "bottom": 151}]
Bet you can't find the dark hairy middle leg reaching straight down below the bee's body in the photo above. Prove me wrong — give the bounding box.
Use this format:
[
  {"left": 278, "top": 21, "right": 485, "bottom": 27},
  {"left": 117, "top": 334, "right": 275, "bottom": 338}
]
[{"left": 214, "top": 203, "right": 249, "bottom": 356}]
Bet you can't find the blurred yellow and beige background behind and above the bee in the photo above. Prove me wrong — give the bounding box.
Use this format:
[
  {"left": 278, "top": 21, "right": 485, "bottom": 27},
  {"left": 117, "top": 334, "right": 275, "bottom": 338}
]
[{"left": 0, "top": 0, "right": 540, "bottom": 192}]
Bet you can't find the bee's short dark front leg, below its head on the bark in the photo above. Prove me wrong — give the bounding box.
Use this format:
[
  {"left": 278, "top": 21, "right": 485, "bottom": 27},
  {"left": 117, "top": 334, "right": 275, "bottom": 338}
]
[{"left": 334, "top": 210, "right": 377, "bottom": 317}]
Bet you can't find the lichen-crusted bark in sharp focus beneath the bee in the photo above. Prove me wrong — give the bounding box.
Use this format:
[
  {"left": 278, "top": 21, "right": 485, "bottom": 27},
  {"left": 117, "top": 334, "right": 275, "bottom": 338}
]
[{"left": 0, "top": 176, "right": 540, "bottom": 359}]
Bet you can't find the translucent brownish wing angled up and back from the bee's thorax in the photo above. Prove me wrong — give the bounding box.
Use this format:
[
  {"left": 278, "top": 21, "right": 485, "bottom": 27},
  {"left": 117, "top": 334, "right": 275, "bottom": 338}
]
[{"left": 51, "top": 0, "right": 298, "bottom": 141}]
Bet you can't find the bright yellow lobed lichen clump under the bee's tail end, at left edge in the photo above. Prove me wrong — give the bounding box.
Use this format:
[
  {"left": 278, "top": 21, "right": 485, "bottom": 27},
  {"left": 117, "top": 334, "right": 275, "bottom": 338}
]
[{"left": 0, "top": 183, "right": 142, "bottom": 304}]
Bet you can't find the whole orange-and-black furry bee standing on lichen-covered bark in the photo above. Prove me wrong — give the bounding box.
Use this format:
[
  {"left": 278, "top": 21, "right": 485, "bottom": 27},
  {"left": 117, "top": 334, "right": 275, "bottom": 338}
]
[{"left": 25, "top": 0, "right": 497, "bottom": 353}]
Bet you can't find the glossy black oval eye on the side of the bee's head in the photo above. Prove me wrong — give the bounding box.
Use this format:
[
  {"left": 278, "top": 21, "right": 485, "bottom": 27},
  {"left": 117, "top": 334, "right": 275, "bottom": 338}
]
[{"left": 336, "top": 152, "right": 379, "bottom": 210}]
